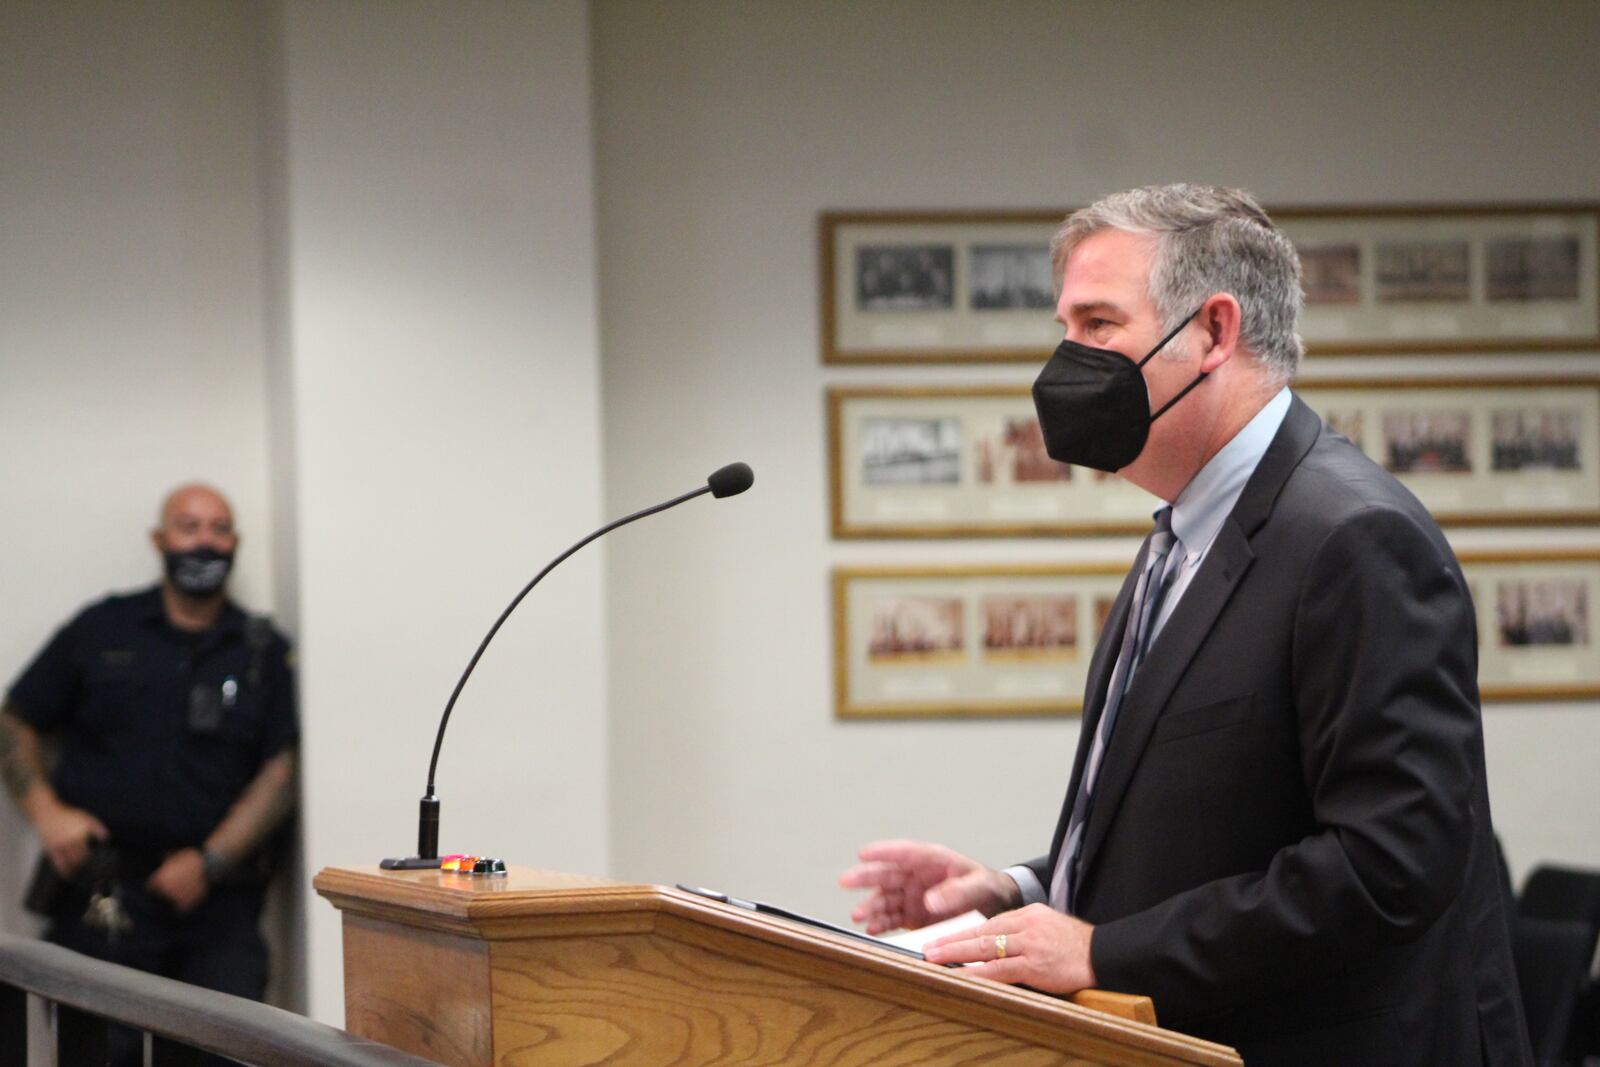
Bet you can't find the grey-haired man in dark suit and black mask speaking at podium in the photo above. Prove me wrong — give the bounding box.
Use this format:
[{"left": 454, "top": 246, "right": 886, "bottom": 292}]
[{"left": 842, "top": 186, "right": 1531, "bottom": 1067}]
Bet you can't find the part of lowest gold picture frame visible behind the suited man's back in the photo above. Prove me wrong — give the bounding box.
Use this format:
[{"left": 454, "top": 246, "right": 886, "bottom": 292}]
[{"left": 1461, "top": 550, "right": 1600, "bottom": 701}]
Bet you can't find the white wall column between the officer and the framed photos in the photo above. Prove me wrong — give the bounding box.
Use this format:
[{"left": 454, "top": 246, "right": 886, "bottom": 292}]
[{"left": 274, "top": 0, "right": 608, "bottom": 1021}]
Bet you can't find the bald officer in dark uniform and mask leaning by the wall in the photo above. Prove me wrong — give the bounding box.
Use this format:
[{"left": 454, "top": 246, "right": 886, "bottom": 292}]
[{"left": 0, "top": 485, "right": 299, "bottom": 1043}]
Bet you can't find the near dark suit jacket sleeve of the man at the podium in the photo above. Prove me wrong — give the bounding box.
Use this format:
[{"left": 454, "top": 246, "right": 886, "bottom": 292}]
[{"left": 1091, "top": 506, "right": 1478, "bottom": 1017}]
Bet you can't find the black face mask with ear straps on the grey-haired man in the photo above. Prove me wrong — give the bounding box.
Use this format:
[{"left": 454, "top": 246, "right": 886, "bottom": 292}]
[{"left": 1034, "top": 307, "right": 1205, "bottom": 474}]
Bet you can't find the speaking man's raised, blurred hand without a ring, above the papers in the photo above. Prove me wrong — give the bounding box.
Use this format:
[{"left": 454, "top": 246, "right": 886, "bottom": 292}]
[{"left": 838, "top": 841, "right": 1022, "bottom": 934}]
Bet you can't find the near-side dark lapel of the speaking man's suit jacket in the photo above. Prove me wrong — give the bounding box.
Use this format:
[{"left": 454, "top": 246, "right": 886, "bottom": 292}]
[{"left": 1056, "top": 397, "right": 1322, "bottom": 893}]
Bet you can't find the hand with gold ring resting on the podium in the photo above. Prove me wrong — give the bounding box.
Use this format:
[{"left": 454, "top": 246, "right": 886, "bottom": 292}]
[{"left": 922, "top": 904, "right": 1094, "bottom": 993}]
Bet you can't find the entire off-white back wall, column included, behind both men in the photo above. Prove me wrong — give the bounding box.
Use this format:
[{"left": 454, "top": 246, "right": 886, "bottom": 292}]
[{"left": 0, "top": 0, "right": 1600, "bottom": 1022}]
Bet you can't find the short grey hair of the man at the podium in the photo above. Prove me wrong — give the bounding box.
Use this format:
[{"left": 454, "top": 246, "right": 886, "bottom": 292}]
[{"left": 1050, "top": 184, "right": 1306, "bottom": 384}]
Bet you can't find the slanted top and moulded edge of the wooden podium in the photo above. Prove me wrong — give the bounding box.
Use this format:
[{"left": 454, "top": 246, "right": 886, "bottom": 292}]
[{"left": 312, "top": 865, "right": 1240, "bottom": 1067}]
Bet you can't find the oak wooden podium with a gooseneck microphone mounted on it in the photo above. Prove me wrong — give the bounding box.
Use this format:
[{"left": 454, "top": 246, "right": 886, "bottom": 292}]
[{"left": 314, "top": 867, "right": 1242, "bottom": 1067}]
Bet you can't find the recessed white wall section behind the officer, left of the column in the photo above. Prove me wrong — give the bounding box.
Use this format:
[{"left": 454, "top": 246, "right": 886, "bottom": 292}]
[{"left": 0, "top": 0, "right": 275, "bottom": 929}]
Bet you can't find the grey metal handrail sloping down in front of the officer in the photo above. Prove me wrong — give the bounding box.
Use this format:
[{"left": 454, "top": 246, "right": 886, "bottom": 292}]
[{"left": 0, "top": 934, "right": 440, "bottom": 1067}]
